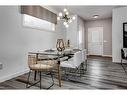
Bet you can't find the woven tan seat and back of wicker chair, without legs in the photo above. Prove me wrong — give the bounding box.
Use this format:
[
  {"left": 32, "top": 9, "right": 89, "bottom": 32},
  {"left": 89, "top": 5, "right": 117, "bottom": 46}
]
[{"left": 28, "top": 54, "right": 57, "bottom": 71}]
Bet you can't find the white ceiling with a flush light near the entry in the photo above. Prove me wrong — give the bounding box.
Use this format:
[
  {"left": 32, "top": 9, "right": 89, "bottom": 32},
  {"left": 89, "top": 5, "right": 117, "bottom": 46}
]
[{"left": 51, "top": 5, "right": 120, "bottom": 20}]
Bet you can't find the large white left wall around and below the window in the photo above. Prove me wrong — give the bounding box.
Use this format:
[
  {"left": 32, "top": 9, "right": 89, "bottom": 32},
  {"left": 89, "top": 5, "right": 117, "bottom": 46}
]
[{"left": 0, "top": 6, "right": 66, "bottom": 82}]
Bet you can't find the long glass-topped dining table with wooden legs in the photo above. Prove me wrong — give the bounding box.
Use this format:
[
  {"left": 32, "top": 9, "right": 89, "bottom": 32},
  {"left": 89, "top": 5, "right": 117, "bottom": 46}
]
[{"left": 28, "top": 49, "right": 79, "bottom": 87}]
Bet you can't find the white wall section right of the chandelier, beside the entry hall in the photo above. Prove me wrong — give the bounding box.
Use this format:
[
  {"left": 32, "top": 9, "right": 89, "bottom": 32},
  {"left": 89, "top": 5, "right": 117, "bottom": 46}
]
[{"left": 66, "top": 15, "right": 85, "bottom": 49}]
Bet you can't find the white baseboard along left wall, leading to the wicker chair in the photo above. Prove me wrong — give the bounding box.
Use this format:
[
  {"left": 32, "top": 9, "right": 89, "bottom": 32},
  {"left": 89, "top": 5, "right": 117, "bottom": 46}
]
[{"left": 0, "top": 70, "right": 29, "bottom": 82}]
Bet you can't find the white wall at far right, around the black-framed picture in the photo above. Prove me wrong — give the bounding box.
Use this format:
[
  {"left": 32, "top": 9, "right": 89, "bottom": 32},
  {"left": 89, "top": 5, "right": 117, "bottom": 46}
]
[{"left": 112, "top": 7, "right": 127, "bottom": 62}]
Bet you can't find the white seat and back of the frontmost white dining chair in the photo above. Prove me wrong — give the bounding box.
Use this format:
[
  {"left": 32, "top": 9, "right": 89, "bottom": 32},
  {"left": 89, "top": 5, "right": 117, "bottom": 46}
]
[{"left": 60, "top": 51, "right": 82, "bottom": 76}]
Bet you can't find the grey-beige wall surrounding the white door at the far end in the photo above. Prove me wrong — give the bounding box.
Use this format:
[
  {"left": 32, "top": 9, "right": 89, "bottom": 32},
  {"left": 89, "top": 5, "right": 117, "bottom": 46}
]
[{"left": 85, "top": 18, "right": 112, "bottom": 56}]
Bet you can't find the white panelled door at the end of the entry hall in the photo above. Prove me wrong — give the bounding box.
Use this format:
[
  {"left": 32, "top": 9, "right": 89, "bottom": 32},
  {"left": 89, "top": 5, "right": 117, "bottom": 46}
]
[{"left": 88, "top": 27, "right": 103, "bottom": 55}]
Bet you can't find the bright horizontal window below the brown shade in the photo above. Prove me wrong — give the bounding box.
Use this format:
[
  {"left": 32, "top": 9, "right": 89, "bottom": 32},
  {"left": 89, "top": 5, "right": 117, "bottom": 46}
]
[{"left": 23, "top": 14, "right": 55, "bottom": 31}]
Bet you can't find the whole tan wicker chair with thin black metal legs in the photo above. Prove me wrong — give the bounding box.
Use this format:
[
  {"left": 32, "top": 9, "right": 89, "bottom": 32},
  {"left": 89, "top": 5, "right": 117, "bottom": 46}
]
[{"left": 26, "top": 54, "right": 56, "bottom": 89}]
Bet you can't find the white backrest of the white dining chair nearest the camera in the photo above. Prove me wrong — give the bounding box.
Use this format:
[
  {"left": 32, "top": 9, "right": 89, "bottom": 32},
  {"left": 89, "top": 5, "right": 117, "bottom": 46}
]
[{"left": 73, "top": 51, "right": 82, "bottom": 67}]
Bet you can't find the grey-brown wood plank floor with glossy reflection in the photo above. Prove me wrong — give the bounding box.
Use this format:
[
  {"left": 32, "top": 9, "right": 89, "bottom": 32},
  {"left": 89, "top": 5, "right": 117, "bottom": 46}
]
[{"left": 0, "top": 56, "right": 127, "bottom": 90}]
